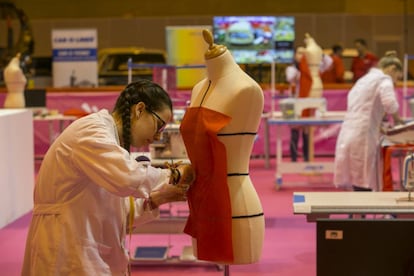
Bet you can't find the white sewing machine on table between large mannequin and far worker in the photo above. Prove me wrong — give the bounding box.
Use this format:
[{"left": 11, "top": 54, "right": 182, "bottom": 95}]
[{"left": 279, "top": 98, "right": 326, "bottom": 119}]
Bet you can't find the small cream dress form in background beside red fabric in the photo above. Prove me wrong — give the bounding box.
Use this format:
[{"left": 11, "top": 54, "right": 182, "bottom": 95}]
[{"left": 305, "top": 33, "right": 323, "bottom": 98}]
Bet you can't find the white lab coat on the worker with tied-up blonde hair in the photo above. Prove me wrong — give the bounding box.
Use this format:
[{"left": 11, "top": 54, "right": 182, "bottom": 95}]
[{"left": 334, "top": 68, "right": 399, "bottom": 191}]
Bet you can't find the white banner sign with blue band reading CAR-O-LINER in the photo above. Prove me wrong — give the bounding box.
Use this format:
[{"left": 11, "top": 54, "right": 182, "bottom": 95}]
[{"left": 52, "top": 29, "right": 98, "bottom": 87}]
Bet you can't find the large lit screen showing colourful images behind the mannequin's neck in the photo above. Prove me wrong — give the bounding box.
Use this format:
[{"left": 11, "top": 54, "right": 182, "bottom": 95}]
[{"left": 213, "top": 16, "right": 295, "bottom": 64}]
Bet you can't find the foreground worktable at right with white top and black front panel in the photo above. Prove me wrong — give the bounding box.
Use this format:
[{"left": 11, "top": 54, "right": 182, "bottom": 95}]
[{"left": 293, "top": 191, "right": 414, "bottom": 276}]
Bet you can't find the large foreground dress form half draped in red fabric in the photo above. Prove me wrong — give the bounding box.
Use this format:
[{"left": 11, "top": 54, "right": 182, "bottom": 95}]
[{"left": 181, "top": 30, "right": 265, "bottom": 264}]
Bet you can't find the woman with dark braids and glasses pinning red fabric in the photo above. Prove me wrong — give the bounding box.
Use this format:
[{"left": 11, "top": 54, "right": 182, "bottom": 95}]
[{"left": 22, "top": 80, "right": 191, "bottom": 276}]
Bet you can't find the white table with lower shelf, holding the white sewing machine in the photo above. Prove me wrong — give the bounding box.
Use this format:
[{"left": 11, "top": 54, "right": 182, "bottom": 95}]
[{"left": 264, "top": 112, "right": 345, "bottom": 189}]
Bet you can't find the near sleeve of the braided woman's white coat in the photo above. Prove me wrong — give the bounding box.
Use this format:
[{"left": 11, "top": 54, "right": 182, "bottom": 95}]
[{"left": 72, "top": 120, "right": 170, "bottom": 198}]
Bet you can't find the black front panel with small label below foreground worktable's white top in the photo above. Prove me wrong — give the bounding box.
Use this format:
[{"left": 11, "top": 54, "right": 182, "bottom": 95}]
[{"left": 316, "top": 218, "right": 414, "bottom": 276}]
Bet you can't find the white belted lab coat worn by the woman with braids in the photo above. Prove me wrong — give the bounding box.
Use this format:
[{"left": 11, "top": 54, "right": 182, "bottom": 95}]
[{"left": 22, "top": 110, "right": 170, "bottom": 276}]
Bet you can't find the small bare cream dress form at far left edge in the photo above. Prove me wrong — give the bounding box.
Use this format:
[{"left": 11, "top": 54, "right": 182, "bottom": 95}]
[{"left": 4, "top": 54, "right": 27, "bottom": 108}]
